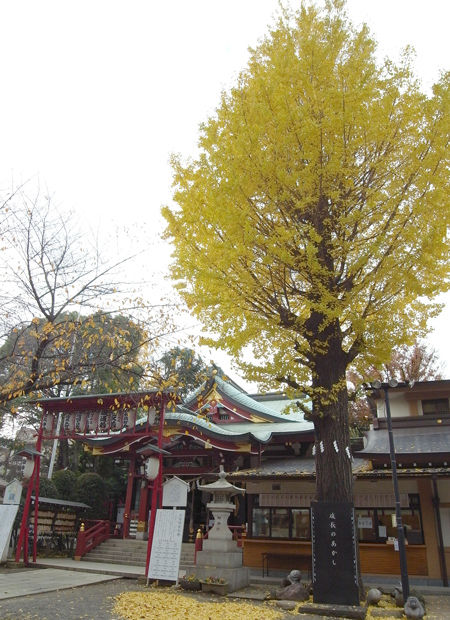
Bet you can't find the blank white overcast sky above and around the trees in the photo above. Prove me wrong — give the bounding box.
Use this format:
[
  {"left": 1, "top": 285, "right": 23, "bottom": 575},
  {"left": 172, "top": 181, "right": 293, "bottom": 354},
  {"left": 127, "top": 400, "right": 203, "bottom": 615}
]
[{"left": 0, "top": 0, "right": 450, "bottom": 382}]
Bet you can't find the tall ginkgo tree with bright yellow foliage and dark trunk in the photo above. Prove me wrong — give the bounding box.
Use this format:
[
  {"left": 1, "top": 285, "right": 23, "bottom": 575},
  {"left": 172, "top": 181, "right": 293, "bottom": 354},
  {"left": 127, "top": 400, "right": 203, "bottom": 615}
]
[{"left": 163, "top": 0, "right": 450, "bottom": 600}]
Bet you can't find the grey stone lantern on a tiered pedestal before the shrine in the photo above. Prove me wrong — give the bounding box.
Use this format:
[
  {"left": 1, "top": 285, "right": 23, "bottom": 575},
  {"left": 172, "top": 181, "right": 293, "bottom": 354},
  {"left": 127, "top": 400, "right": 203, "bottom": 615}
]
[{"left": 195, "top": 466, "right": 249, "bottom": 592}]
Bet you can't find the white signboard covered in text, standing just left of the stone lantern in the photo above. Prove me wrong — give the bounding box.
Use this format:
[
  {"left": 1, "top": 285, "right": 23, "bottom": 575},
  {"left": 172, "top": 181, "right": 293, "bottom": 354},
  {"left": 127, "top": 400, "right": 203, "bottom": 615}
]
[{"left": 147, "top": 509, "right": 185, "bottom": 581}]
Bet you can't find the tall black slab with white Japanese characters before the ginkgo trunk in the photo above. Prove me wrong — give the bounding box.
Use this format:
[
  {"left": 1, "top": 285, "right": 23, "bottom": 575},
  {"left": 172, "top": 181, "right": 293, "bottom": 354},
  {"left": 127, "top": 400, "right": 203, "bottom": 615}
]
[{"left": 311, "top": 501, "right": 359, "bottom": 605}]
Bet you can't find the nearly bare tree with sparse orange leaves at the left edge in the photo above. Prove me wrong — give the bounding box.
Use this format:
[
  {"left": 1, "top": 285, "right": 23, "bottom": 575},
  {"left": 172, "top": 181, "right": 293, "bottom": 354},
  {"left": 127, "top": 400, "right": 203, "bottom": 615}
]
[{"left": 0, "top": 186, "right": 171, "bottom": 424}]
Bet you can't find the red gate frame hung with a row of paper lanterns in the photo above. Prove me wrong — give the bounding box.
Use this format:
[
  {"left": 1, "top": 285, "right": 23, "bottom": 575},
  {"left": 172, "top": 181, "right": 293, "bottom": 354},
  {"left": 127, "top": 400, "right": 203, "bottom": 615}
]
[{"left": 16, "top": 390, "right": 179, "bottom": 573}]
